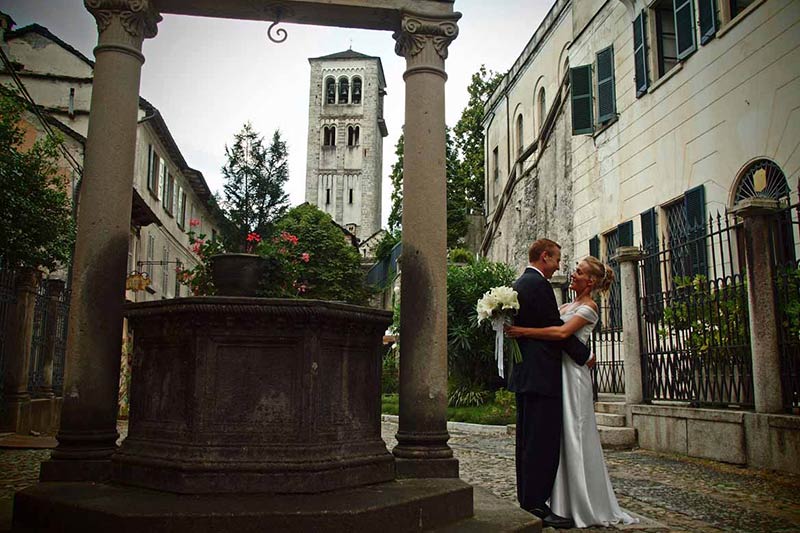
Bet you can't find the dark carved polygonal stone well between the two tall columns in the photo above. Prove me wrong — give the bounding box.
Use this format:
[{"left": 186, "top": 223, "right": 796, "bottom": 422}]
[{"left": 112, "top": 296, "right": 395, "bottom": 494}]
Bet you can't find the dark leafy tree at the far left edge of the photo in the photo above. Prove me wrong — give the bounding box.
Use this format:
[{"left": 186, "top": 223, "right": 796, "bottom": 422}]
[{"left": 0, "top": 89, "right": 75, "bottom": 270}]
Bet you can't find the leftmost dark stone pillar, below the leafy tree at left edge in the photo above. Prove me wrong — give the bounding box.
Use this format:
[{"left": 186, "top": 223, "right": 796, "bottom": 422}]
[{"left": 0, "top": 268, "right": 40, "bottom": 435}]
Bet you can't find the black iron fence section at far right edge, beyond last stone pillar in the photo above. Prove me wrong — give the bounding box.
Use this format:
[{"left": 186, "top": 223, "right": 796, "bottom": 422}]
[{"left": 770, "top": 200, "right": 800, "bottom": 414}]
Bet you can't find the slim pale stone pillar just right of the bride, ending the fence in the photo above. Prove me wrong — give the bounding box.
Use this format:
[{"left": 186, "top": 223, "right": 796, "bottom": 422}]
[{"left": 614, "top": 246, "right": 644, "bottom": 405}]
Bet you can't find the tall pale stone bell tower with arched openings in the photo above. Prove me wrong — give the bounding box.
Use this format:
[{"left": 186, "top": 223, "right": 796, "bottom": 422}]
[{"left": 306, "top": 49, "right": 388, "bottom": 240}]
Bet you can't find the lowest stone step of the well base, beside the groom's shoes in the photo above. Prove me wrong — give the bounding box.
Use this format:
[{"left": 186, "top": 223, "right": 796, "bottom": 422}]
[{"left": 431, "top": 486, "right": 542, "bottom": 533}]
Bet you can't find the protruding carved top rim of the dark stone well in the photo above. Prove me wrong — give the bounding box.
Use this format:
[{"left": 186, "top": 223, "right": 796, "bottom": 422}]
[{"left": 123, "top": 296, "right": 392, "bottom": 326}]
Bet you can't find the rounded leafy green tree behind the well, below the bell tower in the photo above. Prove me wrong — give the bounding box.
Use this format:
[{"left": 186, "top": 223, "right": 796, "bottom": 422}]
[{"left": 276, "top": 203, "right": 370, "bottom": 304}]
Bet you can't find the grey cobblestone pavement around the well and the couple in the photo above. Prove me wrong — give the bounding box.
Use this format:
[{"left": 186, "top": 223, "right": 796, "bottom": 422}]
[{"left": 0, "top": 422, "right": 800, "bottom": 533}]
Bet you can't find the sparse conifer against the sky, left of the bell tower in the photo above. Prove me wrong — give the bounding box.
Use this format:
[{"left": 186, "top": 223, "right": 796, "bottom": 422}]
[{"left": 221, "top": 122, "right": 289, "bottom": 249}]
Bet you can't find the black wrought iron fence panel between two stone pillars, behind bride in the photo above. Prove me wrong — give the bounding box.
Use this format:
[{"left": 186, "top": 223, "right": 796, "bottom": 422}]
[{"left": 638, "top": 213, "right": 754, "bottom": 407}]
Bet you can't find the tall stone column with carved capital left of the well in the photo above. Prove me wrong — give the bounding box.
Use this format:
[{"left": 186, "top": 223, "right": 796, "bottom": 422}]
[{"left": 41, "top": 0, "right": 161, "bottom": 481}]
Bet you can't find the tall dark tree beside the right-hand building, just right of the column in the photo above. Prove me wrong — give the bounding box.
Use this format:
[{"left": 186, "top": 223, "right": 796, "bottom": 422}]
[{"left": 453, "top": 65, "right": 503, "bottom": 211}]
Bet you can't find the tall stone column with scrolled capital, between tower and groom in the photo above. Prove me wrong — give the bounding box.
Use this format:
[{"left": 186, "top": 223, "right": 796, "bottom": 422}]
[{"left": 393, "top": 13, "right": 460, "bottom": 478}]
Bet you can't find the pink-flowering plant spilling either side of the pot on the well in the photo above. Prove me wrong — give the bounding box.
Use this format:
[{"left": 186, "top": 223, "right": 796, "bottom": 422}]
[{"left": 178, "top": 219, "right": 311, "bottom": 298}]
